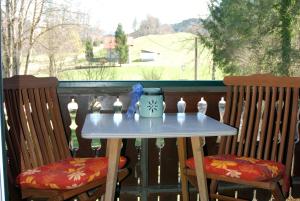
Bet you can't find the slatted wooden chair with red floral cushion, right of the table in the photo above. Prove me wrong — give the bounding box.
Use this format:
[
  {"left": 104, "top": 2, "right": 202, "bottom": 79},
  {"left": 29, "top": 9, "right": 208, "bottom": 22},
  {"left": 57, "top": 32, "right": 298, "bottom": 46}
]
[{"left": 185, "top": 75, "right": 300, "bottom": 200}]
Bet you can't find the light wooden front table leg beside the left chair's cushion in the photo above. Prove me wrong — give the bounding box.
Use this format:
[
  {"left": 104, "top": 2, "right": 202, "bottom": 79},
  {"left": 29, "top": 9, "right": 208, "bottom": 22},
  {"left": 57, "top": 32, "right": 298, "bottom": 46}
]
[{"left": 104, "top": 138, "right": 122, "bottom": 201}]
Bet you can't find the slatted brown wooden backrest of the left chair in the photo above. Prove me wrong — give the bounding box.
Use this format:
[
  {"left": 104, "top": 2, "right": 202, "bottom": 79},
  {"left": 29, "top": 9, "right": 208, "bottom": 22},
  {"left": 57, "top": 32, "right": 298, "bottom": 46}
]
[{"left": 4, "top": 76, "right": 71, "bottom": 171}]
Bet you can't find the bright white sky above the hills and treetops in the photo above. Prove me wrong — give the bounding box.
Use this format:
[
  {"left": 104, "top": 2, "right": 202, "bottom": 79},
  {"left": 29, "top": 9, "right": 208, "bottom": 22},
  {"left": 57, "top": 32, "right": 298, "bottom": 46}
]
[{"left": 72, "top": 0, "right": 209, "bottom": 33}]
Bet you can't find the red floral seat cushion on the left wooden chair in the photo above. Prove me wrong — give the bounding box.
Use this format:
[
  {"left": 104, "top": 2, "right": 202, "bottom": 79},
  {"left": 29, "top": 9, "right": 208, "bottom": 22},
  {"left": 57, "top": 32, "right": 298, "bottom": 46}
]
[{"left": 17, "top": 157, "right": 126, "bottom": 189}]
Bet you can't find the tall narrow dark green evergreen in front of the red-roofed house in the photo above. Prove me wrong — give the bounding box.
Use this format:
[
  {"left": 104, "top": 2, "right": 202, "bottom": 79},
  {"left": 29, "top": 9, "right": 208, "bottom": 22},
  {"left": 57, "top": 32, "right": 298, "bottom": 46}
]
[{"left": 115, "top": 24, "right": 128, "bottom": 64}]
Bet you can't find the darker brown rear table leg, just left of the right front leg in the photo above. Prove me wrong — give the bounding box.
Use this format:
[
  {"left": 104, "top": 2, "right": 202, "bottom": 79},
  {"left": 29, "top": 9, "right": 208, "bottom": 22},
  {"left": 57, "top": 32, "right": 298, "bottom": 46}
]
[{"left": 177, "top": 137, "right": 189, "bottom": 201}]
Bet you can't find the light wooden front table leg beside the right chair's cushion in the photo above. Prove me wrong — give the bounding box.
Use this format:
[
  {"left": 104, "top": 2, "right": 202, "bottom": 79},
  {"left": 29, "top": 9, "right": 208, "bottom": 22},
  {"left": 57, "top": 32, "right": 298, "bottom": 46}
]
[{"left": 191, "top": 137, "right": 208, "bottom": 201}]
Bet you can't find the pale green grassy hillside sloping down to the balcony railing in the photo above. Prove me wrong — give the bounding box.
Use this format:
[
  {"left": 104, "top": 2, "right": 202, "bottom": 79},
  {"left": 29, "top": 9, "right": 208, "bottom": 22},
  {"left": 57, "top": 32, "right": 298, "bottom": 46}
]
[{"left": 59, "top": 33, "right": 223, "bottom": 80}]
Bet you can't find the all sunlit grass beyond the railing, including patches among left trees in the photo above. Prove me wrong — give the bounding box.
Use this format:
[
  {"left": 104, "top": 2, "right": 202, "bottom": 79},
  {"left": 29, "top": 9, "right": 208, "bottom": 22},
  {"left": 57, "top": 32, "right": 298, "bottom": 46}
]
[{"left": 21, "top": 33, "right": 223, "bottom": 80}]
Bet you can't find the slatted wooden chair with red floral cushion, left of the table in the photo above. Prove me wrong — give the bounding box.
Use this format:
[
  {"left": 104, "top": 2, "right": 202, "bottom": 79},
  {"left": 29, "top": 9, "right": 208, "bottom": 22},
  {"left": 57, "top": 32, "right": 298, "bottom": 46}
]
[{"left": 4, "top": 76, "right": 128, "bottom": 200}]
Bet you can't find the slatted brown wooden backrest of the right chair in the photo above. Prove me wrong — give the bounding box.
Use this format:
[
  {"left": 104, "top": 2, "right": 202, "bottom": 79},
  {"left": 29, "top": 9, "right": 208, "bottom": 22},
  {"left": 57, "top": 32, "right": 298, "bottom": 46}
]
[{"left": 218, "top": 75, "right": 300, "bottom": 177}]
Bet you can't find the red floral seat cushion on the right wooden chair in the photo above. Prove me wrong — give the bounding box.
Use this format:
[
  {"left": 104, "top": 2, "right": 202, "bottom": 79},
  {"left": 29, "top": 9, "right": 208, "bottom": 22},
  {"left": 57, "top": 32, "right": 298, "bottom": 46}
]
[{"left": 186, "top": 155, "right": 289, "bottom": 190}]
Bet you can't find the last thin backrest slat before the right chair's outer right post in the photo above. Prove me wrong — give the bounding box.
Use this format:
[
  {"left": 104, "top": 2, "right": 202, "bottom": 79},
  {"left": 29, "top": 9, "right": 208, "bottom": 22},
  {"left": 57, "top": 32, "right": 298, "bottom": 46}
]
[{"left": 278, "top": 88, "right": 291, "bottom": 162}]
